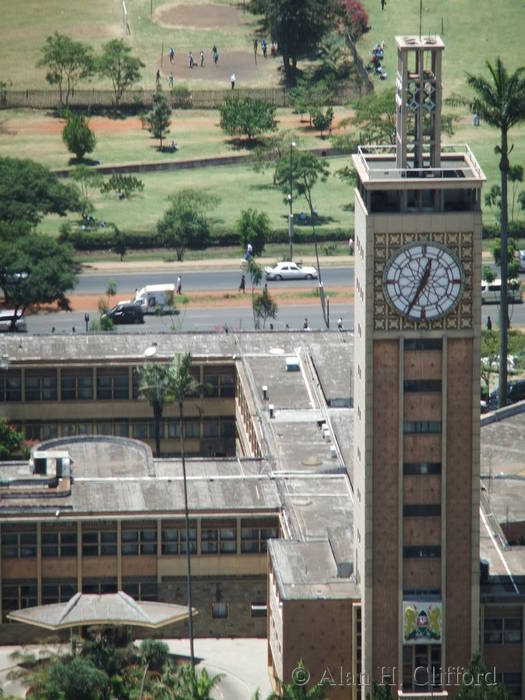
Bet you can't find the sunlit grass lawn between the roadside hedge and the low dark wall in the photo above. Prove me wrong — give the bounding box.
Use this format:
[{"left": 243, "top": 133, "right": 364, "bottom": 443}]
[{"left": 40, "top": 158, "right": 354, "bottom": 234}]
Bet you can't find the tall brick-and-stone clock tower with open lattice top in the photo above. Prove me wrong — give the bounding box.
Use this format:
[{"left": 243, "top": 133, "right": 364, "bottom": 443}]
[{"left": 352, "top": 36, "right": 485, "bottom": 697}]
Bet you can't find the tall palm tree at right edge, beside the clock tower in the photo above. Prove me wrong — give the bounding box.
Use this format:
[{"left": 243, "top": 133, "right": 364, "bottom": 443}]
[{"left": 450, "top": 57, "right": 525, "bottom": 407}]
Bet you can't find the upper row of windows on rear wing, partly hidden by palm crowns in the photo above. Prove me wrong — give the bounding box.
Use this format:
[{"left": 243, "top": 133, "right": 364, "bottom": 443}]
[{"left": 0, "top": 367, "right": 235, "bottom": 401}]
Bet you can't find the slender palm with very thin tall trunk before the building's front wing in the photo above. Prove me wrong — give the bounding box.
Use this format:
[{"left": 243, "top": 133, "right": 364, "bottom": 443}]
[{"left": 169, "top": 352, "right": 197, "bottom": 671}]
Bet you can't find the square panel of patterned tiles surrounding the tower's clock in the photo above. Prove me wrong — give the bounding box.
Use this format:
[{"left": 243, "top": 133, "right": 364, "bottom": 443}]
[{"left": 374, "top": 231, "right": 474, "bottom": 331}]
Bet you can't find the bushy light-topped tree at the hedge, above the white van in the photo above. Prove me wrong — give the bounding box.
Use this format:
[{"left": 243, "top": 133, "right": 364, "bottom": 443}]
[{"left": 157, "top": 190, "right": 217, "bottom": 260}]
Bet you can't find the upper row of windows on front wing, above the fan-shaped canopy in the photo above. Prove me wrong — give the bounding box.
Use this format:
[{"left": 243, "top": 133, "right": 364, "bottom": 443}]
[{"left": 1, "top": 521, "right": 279, "bottom": 559}]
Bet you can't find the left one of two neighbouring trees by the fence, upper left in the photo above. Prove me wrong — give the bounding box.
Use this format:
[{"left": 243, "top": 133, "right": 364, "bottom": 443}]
[{"left": 37, "top": 32, "right": 95, "bottom": 106}]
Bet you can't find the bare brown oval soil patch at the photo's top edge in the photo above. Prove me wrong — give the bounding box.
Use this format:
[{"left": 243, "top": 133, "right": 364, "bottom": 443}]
[{"left": 155, "top": 5, "right": 249, "bottom": 29}]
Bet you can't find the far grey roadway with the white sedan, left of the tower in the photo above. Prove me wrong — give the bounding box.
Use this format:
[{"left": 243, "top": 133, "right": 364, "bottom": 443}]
[{"left": 75, "top": 266, "right": 354, "bottom": 298}]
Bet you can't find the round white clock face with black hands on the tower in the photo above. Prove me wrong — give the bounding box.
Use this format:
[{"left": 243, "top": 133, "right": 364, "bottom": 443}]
[{"left": 383, "top": 243, "right": 463, "bottom": 321}]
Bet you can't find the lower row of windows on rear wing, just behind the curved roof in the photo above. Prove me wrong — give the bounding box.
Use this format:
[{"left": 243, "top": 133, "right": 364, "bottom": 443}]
[{"left": 20, "top": 417, "right": 235, "bottom": 441}]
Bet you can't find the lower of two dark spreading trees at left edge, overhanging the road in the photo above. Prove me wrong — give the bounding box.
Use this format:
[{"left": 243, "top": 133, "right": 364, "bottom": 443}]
[{"left": 0, "top": 233, "right": 79, "bottom": 322}]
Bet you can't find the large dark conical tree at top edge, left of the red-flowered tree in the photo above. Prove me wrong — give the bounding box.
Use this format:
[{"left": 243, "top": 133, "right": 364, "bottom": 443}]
[{"left": 256, "top": 0, "right": 336, "bottom": 85}]
